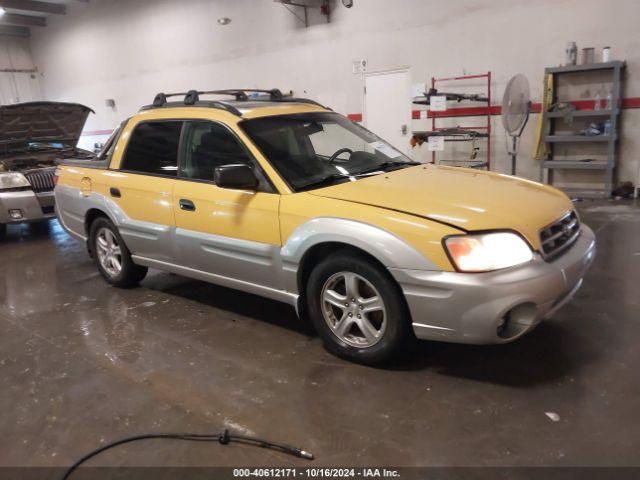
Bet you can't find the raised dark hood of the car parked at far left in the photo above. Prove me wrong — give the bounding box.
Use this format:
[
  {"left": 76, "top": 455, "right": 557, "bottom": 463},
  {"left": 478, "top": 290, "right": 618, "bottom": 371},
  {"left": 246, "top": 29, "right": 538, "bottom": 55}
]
[{"left": 0, "top": 102, "right": 95, "bottom": 151}]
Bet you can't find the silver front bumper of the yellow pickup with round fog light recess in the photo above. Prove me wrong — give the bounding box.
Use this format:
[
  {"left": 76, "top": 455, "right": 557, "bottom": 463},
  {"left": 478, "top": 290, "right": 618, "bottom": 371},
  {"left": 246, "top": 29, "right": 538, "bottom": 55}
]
[{"left": 390, "top": 225, "right": 596, "bottom": 344}]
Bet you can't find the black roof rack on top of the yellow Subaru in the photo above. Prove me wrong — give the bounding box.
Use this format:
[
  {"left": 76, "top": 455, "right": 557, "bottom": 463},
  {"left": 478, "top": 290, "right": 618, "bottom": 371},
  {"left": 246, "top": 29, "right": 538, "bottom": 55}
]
[{"left": 142, "top": 88, "right": 331, "bottom": 117}]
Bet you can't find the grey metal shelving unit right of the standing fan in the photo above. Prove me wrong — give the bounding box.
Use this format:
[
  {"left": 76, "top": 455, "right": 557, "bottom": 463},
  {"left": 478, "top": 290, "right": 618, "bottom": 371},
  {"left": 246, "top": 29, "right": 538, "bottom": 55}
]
[{"left": 540, "top": 61, "right": 625, "bottom": 198}]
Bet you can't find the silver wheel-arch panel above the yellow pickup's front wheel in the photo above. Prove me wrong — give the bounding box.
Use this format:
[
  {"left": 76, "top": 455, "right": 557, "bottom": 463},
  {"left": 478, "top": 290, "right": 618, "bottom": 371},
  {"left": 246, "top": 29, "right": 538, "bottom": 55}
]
[{"left": 281, "top": 217, "right": 440, "bottom": 292}]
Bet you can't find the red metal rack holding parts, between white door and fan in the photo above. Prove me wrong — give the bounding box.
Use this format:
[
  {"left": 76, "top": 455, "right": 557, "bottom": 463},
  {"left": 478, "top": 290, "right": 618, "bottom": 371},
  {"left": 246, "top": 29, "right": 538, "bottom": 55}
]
[{"left": 428, "top": 72, "right": 491, "bottom": 170}]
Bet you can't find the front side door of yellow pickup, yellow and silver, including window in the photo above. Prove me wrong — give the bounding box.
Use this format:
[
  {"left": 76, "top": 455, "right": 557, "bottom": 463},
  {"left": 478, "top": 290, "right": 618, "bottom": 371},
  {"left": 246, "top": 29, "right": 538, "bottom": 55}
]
[{"left": 173, "top": 121, "right": 280, "bottom": 287}]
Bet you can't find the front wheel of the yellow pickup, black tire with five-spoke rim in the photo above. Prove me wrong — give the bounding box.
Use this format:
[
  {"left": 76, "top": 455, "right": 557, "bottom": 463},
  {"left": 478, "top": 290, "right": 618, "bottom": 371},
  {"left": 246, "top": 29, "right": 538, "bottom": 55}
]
[{"left": 306, "top": 251, "right": 412, "bottom": 365}]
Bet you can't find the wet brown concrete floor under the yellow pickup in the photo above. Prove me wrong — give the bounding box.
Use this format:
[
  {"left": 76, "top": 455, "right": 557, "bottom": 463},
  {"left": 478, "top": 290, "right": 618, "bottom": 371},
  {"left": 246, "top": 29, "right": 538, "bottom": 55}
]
[{"left": 0, "top": 201, "right": 640, "bottom": 466}]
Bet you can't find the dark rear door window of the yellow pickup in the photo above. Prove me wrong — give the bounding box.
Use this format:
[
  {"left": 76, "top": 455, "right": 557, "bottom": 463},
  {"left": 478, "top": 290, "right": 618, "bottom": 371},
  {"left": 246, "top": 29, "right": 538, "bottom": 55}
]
[{"left": 120, "top": 121, "right": 183, "bottom": 177}]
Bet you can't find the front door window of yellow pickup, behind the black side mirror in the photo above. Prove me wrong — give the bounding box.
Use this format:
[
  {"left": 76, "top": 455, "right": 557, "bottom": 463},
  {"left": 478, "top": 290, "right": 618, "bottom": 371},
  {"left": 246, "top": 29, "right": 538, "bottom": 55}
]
[{"left": 180, "top": 121, "right": 254, "bottom": 182}]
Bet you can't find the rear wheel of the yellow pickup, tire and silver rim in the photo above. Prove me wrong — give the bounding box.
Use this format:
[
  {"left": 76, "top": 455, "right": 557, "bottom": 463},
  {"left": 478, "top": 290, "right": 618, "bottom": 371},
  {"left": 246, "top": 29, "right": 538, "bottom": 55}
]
[{"left": 89, "top": 217, "right": 148, "bottom": 288}]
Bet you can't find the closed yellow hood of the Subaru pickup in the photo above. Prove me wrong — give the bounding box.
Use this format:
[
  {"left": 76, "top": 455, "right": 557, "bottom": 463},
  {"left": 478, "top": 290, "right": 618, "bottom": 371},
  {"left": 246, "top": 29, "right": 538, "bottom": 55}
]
[{"left": 307, "top": 165, "right": 573, "bottom": 249}]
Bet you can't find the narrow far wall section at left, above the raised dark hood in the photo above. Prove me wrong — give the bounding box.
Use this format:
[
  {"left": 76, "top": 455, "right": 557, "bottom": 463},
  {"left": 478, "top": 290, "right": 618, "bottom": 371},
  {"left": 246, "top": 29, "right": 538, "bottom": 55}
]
[{"left": 0, "top": 35, "right": 41, "bottom": 105}]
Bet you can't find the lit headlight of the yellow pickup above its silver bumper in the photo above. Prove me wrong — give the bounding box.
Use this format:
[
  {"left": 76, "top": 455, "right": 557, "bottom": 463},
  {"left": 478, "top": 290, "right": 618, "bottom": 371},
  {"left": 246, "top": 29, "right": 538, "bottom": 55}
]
[{"left": 444, "top": 232, "right": 533, "bottom": 272}]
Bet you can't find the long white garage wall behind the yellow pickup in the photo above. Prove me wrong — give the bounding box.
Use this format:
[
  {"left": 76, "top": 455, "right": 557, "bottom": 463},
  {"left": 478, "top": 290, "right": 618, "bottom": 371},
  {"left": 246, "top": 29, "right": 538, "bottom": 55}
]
[{"left": 31, "top": 0, "right": 640, "bottom": 186}]
